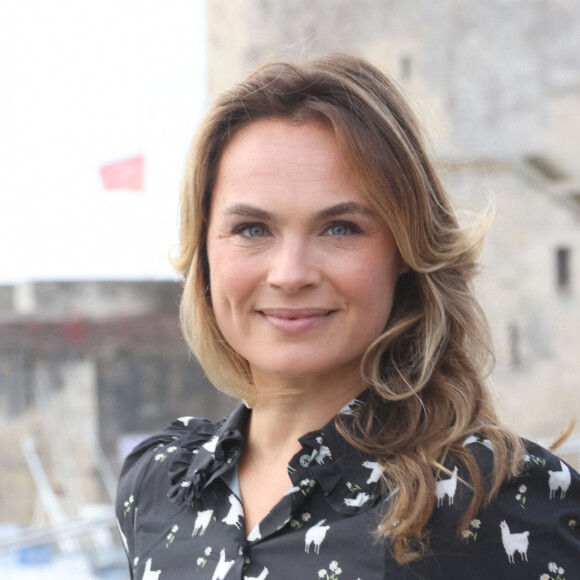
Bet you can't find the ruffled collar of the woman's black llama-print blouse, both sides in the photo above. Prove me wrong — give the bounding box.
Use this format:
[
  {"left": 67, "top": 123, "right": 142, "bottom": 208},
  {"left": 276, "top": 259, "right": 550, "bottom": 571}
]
[{"left": 168, "top": 391, "right": 383, "bottom": 514}]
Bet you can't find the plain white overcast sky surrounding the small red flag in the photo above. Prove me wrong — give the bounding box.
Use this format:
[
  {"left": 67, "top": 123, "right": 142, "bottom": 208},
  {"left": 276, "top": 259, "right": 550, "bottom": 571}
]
[{"left": 0, "top": 0, "right": 206, "bottom": 284}]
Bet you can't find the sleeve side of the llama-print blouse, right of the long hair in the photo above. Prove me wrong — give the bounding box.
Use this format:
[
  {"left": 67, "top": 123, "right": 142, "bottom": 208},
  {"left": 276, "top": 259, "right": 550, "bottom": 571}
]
[{"left": 412, "top": 441, "right": 580, "bottom": 580}]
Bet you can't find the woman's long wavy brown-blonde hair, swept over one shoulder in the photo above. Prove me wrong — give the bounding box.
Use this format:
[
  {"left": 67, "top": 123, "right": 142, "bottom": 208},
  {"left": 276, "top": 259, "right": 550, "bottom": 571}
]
[{"left": 173, "top": 54, "right": 523, "bottom": 563}]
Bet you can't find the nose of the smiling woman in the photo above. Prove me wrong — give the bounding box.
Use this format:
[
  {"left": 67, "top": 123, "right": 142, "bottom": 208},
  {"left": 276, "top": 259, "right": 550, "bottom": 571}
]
[{"left": 268, "top": 239, "right": 321, "bottom": 294}]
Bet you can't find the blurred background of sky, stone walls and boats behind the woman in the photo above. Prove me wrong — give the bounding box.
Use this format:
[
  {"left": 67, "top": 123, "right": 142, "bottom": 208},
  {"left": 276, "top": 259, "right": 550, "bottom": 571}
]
[{"left": 0, "top": 0, "right": 580, "bottom": 580}]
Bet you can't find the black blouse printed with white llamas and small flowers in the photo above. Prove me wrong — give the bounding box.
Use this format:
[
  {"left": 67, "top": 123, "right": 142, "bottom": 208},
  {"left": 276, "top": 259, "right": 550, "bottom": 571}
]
[{"left": 117, "top": 399, "right": 580, "bottom": 580}]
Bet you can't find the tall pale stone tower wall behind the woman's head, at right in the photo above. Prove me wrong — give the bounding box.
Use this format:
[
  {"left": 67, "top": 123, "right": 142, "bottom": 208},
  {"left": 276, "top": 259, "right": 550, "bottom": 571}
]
[{"left": 208, "top": 0, "right": 580, "bottom": 466}]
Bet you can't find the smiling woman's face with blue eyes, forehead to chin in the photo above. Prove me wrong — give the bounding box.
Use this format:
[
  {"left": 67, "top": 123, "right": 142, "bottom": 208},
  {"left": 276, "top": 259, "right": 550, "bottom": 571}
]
[{"left": 207, "top": 119, "right": 399, "bottom": 385}]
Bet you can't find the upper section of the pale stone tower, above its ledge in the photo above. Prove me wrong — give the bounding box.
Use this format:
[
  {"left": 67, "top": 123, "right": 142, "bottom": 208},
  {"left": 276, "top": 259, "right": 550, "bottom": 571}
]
[{"left": 208, "top": 0, "right": 580, "bottom": 161}]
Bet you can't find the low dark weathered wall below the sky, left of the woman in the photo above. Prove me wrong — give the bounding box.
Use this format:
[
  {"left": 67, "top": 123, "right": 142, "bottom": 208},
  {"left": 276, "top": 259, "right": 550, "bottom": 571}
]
[{"left": 0, "top": 282, "right": 235, "bottom": 524}]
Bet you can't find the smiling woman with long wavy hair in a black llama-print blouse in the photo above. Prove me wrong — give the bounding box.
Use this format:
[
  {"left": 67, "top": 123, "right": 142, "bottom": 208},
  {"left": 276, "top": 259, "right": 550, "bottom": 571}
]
[{"left": 118, "top": 55, "right": 580, "bottom": 580}]
